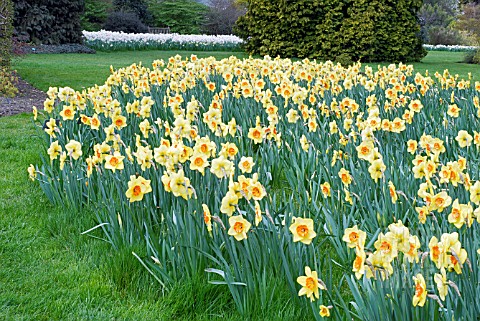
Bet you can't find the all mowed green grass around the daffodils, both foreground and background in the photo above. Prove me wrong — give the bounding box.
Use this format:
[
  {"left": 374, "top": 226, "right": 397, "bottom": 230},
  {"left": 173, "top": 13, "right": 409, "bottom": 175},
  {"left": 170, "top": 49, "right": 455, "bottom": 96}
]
[{"left": 0, "top": 51, "right": 480, "bottom": 320}]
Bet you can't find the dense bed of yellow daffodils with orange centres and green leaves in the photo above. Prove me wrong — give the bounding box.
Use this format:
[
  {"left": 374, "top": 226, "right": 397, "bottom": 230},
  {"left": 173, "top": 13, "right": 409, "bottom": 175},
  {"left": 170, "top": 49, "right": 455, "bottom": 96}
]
[{"left": 29, "top": 55, "right": 480, "bottom": 320}]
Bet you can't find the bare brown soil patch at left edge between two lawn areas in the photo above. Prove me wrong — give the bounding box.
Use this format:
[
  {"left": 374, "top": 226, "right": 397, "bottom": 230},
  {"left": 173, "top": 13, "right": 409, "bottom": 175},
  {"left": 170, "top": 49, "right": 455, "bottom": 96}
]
[{"left": 0, "top": 75, "right": 47, "bottom": 117}]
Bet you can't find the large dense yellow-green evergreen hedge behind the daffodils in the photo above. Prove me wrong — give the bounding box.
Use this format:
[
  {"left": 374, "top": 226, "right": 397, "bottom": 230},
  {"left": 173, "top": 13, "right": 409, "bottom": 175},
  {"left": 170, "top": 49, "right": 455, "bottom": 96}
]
[{"left": 236, "top": 0, "right": 426, "bottom": 63}]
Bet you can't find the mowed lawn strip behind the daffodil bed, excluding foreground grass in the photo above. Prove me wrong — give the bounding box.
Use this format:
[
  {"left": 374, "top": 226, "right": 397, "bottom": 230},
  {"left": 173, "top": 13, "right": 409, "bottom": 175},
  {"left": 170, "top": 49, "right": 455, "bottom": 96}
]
[{"left": 14, "top": 51, "right": 480, "bottom": 91}]
